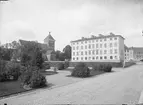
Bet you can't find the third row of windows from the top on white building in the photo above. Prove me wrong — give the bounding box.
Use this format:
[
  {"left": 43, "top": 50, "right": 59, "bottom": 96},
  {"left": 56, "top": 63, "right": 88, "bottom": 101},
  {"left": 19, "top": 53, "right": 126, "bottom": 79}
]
[{"left": 73, "top": 49, "right": 118, "bottom": 56}]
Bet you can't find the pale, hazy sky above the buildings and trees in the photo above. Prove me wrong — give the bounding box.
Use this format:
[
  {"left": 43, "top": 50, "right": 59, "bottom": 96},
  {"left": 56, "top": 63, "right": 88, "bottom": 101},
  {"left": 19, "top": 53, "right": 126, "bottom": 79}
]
[{"left": 0, "top": 0, "right": 143, "bottom": 50}]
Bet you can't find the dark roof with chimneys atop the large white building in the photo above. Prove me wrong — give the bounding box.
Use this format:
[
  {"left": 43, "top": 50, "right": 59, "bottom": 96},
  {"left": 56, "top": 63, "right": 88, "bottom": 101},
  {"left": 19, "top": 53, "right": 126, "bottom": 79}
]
[{"left": 71, "top": 33, "right": 125, "bottom": 42}]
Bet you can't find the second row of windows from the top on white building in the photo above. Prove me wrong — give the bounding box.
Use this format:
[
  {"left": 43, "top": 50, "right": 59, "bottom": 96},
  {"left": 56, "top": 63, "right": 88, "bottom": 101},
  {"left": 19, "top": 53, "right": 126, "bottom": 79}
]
[{"left": 73, "top": 42, "right": 117, "bottom": 50}]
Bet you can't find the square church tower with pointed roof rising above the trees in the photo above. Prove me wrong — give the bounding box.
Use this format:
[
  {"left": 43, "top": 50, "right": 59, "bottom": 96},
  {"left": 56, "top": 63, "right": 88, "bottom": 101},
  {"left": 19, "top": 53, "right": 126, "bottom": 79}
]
[{"left": 44, "top": 32, "right": 55, "bottom": 50}]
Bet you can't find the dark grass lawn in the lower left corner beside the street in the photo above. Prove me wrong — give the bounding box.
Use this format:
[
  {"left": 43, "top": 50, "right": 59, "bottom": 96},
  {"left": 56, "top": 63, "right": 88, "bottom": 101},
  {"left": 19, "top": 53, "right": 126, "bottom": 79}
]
[{"left": 0, "top": 81, "right": 26, "bottom": 97}]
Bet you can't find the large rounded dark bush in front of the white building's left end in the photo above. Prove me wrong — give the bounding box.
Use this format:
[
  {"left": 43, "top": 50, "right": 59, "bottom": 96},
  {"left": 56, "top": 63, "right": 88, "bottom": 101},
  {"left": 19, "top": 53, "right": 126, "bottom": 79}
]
[{"left": 71, "top": 62, "right": 90, "bottom": 77}]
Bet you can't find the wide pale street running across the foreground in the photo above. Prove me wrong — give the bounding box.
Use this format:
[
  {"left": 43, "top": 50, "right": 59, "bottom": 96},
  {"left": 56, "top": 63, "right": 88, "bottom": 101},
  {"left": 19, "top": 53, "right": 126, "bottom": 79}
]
[{"left": 0, "top": 64, "right": 143, "bottom": 105}]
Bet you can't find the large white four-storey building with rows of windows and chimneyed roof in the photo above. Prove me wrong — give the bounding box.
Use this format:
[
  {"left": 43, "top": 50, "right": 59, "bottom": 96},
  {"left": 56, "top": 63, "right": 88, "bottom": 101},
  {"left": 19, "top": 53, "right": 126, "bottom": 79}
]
[{"left": 71, "top": 33, "right": 125, "bottom": 62}]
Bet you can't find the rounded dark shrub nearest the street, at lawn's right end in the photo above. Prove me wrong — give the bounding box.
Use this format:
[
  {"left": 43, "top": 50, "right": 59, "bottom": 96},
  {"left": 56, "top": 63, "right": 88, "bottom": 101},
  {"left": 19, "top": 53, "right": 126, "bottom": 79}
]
[{"left": 29, "top": 71, "right": 46, "bottom": 88}]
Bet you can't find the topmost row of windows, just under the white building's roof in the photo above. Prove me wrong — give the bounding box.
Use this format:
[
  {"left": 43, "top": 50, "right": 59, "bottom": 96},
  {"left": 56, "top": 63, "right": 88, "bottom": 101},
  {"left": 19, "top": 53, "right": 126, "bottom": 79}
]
[{"left": 72, "top": 37, "right": 117, "bottom": 45}]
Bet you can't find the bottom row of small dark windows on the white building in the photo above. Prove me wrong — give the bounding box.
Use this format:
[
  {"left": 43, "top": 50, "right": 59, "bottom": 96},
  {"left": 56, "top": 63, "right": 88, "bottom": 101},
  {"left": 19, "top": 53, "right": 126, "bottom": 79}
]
[{"left": 73, "top": 56, "right": 118, "bottom": 60}]
